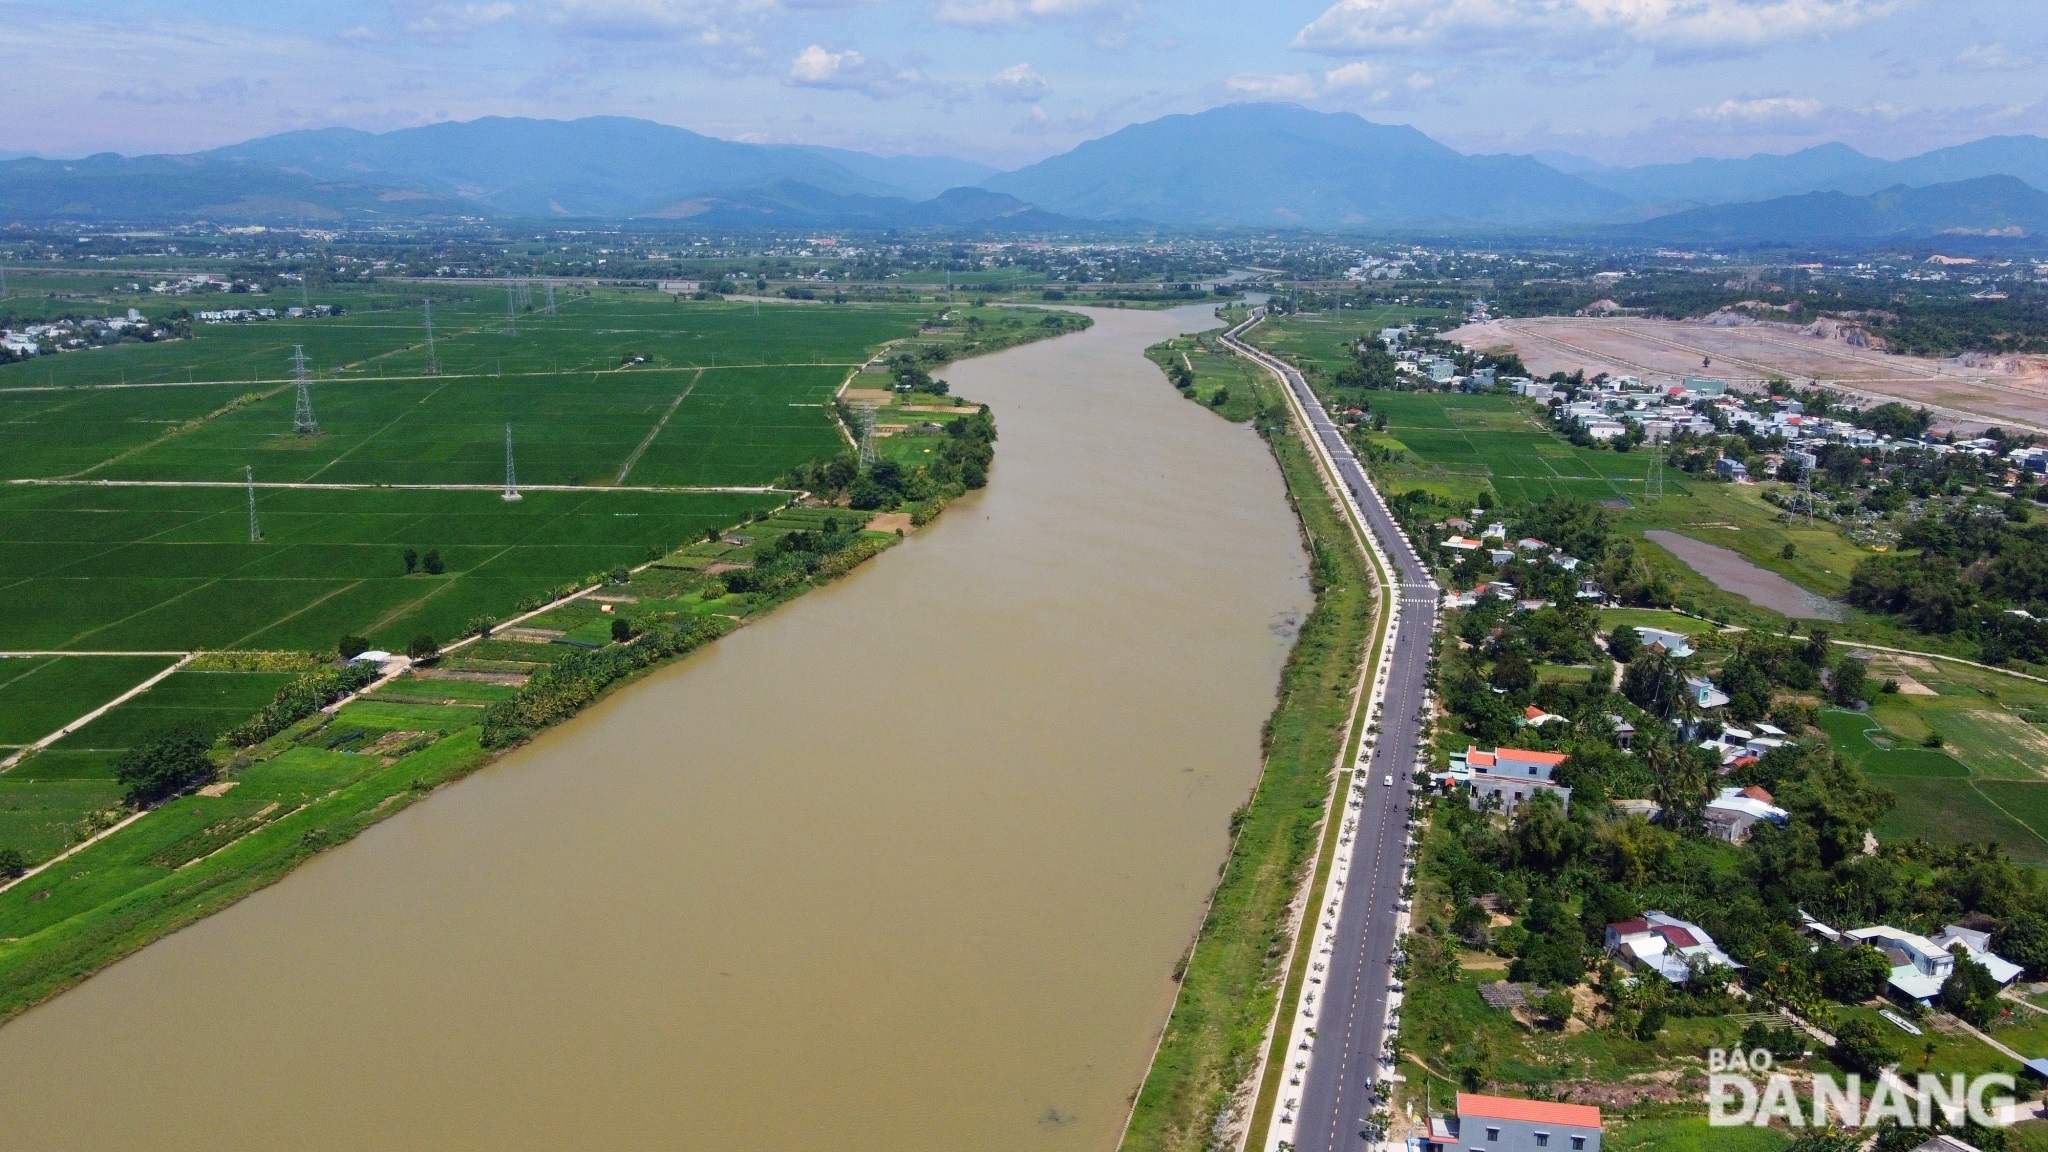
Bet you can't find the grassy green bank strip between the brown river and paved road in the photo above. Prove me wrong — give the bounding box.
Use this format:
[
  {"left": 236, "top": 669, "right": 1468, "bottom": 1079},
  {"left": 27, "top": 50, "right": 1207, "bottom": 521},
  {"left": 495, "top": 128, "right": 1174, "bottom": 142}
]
[{"left": 1122, "top": 338, "right": 1374, "bottom": 1152}]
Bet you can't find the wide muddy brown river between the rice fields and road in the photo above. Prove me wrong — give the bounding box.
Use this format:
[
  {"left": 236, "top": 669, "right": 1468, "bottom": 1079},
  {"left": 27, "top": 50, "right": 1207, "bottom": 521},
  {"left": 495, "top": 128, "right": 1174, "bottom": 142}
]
[{"left": 0, "top": 310, "right": 1311, "bottom": 1152}]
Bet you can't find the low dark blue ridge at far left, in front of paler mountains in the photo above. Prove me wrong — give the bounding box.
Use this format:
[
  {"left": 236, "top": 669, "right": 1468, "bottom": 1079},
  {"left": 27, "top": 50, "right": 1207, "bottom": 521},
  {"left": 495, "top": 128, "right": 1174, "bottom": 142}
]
[{"left": 0, "top": 152, "right": 475, "bottom": 221}]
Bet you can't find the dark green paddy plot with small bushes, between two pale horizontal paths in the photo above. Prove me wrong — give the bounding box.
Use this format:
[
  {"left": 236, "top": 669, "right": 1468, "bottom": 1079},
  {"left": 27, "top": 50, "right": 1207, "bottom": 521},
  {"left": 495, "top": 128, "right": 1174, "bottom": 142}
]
[{"left": 0, "top": 486, "right": 782, "bottom": 652}]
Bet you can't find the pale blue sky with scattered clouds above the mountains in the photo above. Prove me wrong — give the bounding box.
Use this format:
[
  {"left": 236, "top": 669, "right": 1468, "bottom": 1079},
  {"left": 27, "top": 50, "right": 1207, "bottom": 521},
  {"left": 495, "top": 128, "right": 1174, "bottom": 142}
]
[{"left": 0, "top": 0, "right": 2048, "bottom": 168}]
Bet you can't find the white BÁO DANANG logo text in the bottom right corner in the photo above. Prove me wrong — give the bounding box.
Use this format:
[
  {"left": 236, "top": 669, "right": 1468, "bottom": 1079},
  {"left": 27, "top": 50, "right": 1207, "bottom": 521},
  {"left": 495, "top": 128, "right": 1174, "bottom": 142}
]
[{"left": 1706, "top": 1047, "right": 2017, "bottom": 1127}]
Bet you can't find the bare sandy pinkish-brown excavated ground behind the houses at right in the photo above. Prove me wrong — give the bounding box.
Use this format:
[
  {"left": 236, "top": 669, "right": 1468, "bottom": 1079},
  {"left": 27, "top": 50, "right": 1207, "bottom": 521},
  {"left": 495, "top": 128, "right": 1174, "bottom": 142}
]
[{"left": 1446, "top": 314, "right": 2048, "bottom": 433}]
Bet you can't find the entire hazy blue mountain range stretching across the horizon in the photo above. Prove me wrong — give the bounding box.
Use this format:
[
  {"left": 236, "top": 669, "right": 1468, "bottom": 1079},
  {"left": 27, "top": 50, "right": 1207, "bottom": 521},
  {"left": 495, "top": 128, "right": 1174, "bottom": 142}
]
[{"left": 0, "top": 105, "right": 2048, "bottom": 244}]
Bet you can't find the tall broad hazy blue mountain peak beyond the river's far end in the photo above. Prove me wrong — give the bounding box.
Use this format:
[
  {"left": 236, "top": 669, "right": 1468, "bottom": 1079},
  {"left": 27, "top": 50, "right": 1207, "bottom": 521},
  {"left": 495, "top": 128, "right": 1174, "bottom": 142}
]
[{"left": 981, "top": 105, "right": 1626, "bottom": 230}]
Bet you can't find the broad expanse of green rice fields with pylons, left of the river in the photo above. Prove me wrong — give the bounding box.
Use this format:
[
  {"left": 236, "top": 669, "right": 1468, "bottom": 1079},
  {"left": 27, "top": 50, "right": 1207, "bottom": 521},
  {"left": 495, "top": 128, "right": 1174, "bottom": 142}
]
[{"left": 0, "top": 285, "right": 932, "bottom": 655}]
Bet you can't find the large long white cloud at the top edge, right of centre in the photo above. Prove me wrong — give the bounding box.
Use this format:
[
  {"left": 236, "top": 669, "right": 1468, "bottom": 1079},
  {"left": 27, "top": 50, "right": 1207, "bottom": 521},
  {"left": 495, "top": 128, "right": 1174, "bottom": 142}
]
[{"left": 1292, "top": 0, "right": 1911, "bottom": 55}]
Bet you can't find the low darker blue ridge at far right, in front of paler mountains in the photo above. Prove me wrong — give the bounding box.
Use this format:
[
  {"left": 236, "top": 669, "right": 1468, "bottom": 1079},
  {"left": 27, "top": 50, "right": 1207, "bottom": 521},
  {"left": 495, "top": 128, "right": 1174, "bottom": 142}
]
[{"left": 1606, "top": 176, "right": 2048, "bottom": 244}]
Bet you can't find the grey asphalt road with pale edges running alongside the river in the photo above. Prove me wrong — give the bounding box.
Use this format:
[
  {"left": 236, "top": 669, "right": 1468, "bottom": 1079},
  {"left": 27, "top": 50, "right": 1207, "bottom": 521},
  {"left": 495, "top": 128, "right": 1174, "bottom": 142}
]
[{"left": 1229, "top": 313, "right": 1436, "bottom": 1152}]
